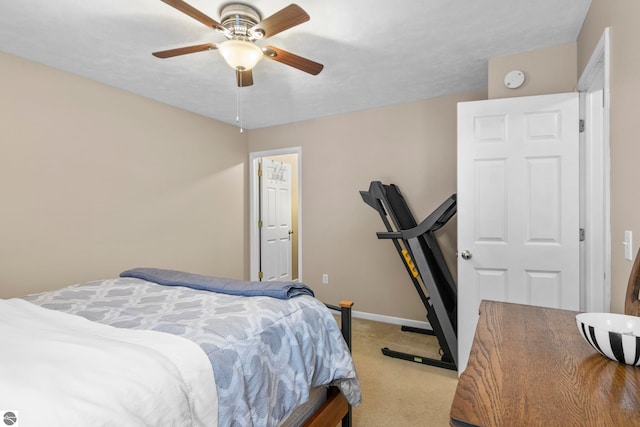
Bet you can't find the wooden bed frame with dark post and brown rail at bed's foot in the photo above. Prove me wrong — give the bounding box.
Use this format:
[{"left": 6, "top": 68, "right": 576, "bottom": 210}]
[{"left": 303, "top": 301, "right": 353, "bottom": 427}]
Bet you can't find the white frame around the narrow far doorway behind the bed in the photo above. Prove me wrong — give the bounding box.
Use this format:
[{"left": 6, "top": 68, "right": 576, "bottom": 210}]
[{"left": 249, "top": 147, "right": 302, "bottom": 281}]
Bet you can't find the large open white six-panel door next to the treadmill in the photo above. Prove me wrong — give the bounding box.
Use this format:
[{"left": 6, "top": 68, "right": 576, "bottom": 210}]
[{"left": 458, "top": 93, "right": 580, "bottom": 372}]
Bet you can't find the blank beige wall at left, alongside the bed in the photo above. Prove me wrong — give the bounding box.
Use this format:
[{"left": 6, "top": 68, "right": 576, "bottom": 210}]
[{"left": 0, "top": 53, "right": 248, "bottom": 298}]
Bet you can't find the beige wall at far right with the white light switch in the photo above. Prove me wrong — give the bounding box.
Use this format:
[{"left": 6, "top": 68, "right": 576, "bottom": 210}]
[{"left": 577, "top": 0, "right": 640, "bottom": 312}]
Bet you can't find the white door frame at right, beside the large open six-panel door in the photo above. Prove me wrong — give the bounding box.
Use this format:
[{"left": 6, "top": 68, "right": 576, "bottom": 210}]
[{"left": 578, "top": 27, "right": 611, "bottom": 312}]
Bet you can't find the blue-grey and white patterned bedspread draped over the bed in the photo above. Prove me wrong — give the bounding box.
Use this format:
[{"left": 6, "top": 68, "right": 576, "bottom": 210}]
[{"left": 25, "top": 278, "right": 361, "bottom": 427}]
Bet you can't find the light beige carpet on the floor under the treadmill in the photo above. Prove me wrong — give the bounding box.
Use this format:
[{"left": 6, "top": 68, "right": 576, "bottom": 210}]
[{"left": 352, "top": 318, "right": 458, "bottom": 427}]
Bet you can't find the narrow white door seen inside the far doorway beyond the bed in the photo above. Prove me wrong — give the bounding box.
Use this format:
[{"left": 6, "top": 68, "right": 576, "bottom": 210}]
[{"left": 260, "top": 158, "right": 292, "bottom": 281}]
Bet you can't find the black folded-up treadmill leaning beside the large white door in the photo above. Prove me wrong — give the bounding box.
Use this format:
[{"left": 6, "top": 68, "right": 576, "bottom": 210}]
[{"left": 360, "top": 181, "right": 458, "bottom": 370}]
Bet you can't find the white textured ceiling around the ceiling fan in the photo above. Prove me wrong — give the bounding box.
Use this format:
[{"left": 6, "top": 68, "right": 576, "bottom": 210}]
[{"left": 0, "top": 0, "right": 591, "bottom": 129}]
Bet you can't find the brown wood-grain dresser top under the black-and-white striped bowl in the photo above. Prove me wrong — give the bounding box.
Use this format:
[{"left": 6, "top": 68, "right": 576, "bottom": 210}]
[{"left": 450, "top": 301, "right": 640, "bottom": 427}]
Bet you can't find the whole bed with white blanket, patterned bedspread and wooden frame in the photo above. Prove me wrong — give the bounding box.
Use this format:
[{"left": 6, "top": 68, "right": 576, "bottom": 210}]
[{"left": 0, "top": 268, "right": 361, "bottom": 427}]
